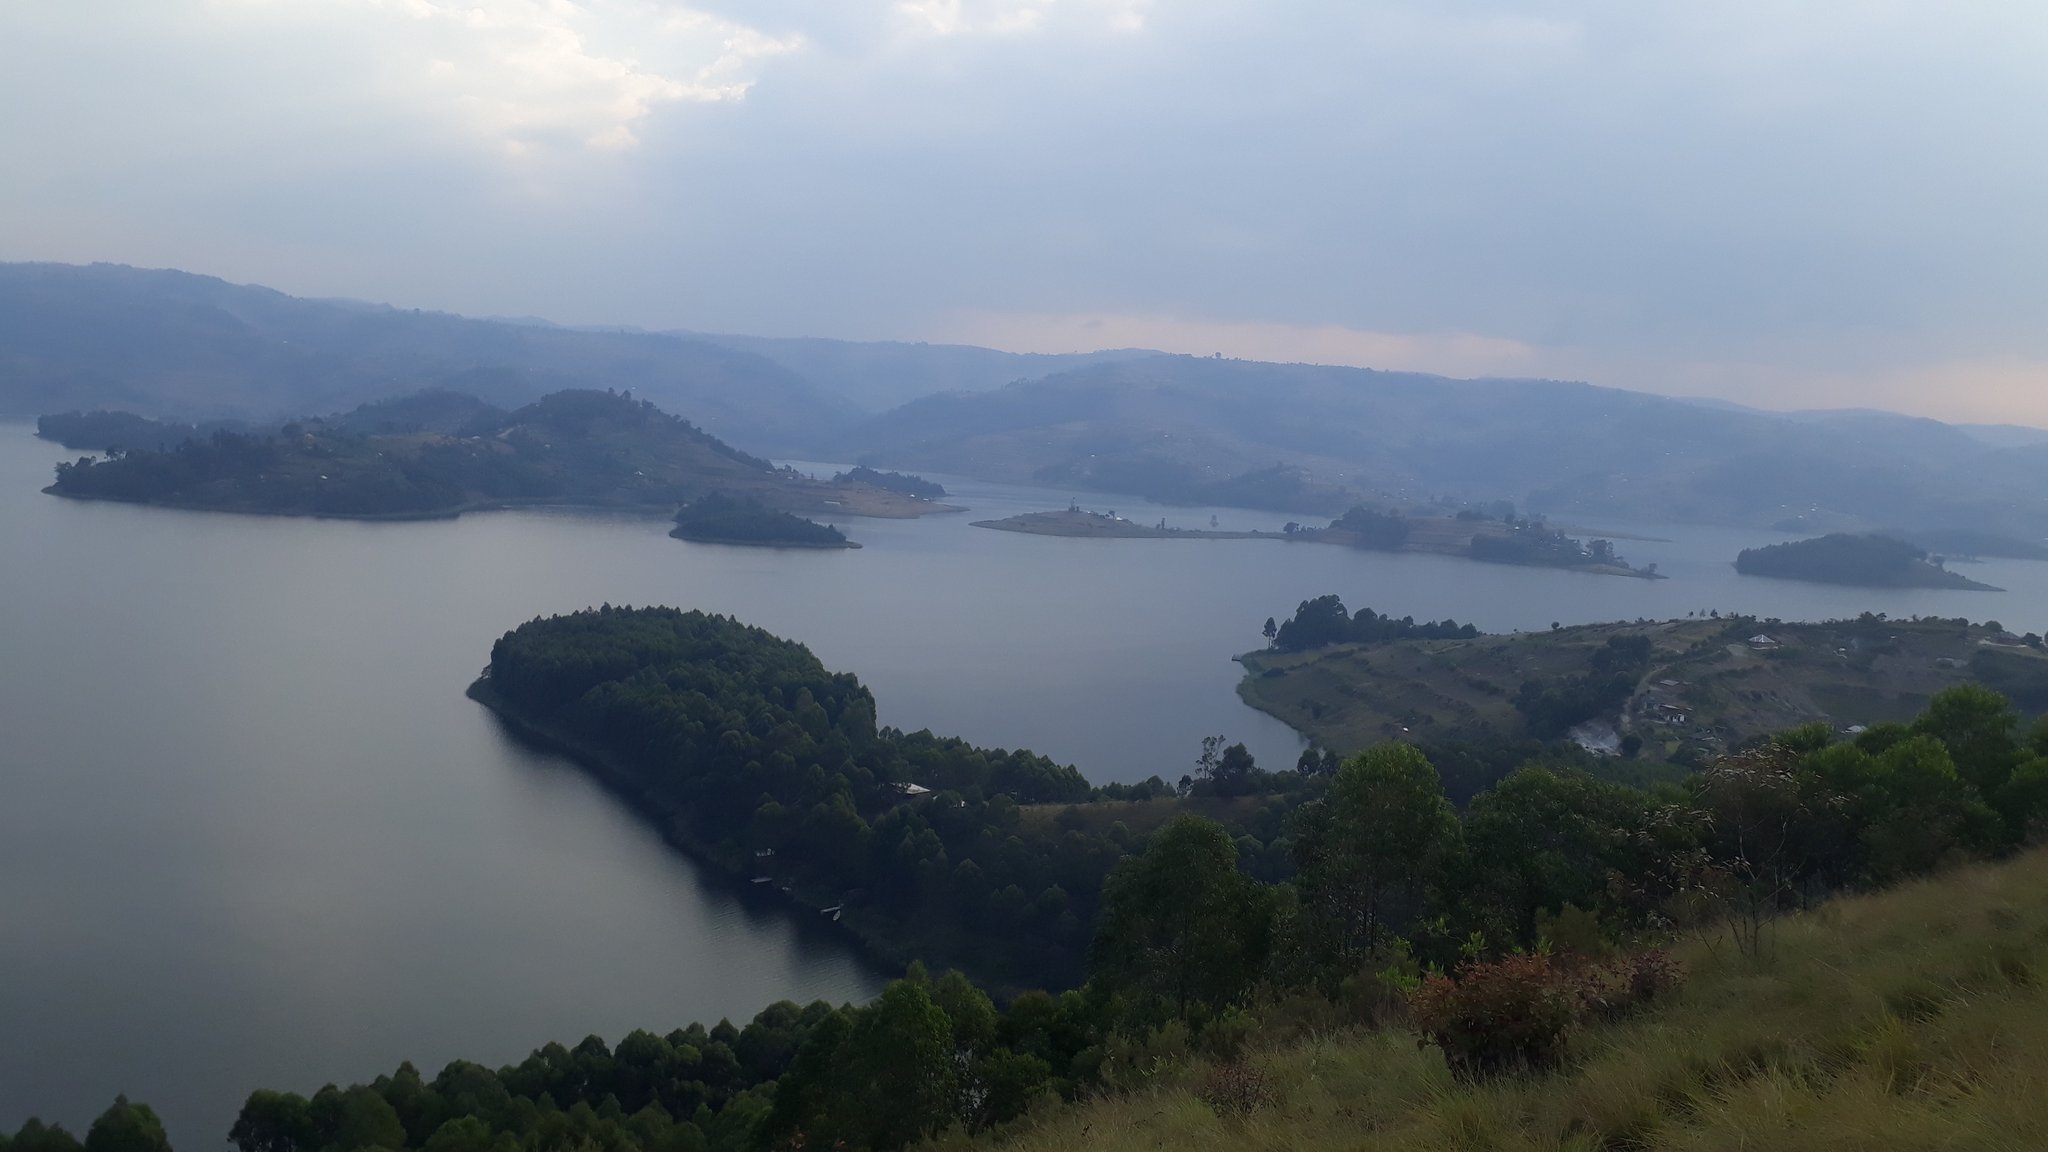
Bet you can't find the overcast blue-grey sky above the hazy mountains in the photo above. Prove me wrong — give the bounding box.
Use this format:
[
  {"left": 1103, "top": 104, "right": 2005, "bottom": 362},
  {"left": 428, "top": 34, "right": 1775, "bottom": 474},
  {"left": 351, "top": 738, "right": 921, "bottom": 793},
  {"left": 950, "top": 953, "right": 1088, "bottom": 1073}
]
[{"left": 0, "top": 0, "right": 2048, "bottom": 424}]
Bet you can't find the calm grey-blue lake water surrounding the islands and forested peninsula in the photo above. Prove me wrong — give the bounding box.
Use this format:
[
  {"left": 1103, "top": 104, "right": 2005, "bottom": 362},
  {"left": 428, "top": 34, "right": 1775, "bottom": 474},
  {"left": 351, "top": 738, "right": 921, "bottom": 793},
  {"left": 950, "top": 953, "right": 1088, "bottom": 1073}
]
[{"left": 0, "top": 424, "right": 2048, "bottom": 1152}]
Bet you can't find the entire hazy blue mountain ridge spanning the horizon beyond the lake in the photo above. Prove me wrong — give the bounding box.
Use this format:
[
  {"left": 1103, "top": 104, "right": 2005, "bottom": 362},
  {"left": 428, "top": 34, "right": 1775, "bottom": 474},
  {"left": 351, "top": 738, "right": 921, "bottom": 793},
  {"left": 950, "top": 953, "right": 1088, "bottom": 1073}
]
[{"left": 16, "top": 264, "right": 2048, "bottom": 543}]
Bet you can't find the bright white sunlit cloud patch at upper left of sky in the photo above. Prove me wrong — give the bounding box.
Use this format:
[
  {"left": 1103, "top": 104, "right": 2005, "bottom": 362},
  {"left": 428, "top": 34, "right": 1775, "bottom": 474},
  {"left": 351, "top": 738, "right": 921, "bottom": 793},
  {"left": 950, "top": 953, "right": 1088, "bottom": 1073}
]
[{"left": 213, "top": 0, "right": 803, "bottom": 156}]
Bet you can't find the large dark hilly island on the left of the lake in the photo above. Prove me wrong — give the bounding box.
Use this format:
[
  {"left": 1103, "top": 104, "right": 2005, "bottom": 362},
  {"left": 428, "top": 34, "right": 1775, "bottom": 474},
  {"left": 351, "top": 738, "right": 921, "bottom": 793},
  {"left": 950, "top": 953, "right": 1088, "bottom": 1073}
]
[{"left": 47, "top": 389, "right": 950, "bottom": 519}]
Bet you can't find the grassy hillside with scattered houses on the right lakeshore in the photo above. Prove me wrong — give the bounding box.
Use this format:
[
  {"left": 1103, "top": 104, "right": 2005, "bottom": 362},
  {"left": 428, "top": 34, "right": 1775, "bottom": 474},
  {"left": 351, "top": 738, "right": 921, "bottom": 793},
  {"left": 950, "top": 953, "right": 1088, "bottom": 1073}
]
[{"left": 1237, "top": 617, "right": 2048, "bottom": 763}]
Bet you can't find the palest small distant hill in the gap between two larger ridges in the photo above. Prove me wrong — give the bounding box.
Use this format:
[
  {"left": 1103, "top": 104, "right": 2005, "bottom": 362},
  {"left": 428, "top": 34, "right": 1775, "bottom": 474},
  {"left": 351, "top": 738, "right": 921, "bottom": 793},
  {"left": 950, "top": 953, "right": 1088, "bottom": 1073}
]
[{"left": 678, "top": 332, "right": 1159, "bottom": 412}]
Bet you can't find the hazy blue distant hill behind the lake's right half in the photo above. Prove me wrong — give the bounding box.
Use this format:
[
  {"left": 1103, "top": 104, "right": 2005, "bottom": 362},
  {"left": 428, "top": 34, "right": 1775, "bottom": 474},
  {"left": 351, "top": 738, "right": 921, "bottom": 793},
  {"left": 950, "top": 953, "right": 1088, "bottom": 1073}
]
[{"left": 842, "top": 357, "right": 2048, "bottom": 539}]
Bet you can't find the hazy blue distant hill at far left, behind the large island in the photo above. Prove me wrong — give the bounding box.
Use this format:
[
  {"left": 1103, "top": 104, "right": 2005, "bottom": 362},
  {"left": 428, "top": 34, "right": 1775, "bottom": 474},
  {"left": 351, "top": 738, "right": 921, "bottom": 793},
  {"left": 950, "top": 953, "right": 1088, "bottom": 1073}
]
[{"left": 0, "top": 264, "right": 860, "bottom": 451}]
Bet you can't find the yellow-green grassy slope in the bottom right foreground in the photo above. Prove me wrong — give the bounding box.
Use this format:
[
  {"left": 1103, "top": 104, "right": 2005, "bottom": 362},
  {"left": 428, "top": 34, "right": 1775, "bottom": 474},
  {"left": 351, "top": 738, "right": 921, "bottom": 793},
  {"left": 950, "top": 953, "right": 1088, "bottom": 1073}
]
[{"left": 942, "top": 853, "right": 2048, "bottom": 1152}]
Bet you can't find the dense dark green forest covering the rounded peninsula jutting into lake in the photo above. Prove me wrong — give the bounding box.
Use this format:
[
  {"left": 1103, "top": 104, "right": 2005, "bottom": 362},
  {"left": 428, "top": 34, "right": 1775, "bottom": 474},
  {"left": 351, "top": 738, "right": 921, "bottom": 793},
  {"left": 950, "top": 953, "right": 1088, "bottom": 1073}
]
[{"left": 483, "top": 609, "right": 1165, "bottom": 988}]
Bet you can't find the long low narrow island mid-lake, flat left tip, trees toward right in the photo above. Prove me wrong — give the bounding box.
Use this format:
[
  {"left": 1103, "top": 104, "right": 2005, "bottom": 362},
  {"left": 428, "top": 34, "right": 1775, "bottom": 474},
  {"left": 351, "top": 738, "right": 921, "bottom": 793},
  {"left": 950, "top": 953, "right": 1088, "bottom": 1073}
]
[{"left": 973, "top": 504, "right": 1665, "bottom": 580}]
